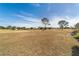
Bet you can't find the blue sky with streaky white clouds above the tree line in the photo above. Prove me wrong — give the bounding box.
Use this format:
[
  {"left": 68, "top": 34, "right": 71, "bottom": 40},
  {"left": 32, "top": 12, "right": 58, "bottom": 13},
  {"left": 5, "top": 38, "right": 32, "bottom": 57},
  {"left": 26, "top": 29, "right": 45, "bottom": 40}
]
[{"left": 0, "top": 3, "right": 79, "bottom": 27}]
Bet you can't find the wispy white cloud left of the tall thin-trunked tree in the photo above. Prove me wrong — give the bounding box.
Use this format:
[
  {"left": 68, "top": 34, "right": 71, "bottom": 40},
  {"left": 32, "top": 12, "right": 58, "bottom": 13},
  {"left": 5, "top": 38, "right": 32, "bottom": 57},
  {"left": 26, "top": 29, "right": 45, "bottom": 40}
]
[{"left": 14, "top": 14, "right": 41, "bottom": 27}]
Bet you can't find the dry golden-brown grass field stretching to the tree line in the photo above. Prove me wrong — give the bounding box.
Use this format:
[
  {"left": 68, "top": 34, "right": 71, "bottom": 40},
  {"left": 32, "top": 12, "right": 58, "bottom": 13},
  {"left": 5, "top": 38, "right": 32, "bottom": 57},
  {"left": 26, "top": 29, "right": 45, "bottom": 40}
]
[{"left": 0, "top": 29, "right": 79, "bottom": 56}]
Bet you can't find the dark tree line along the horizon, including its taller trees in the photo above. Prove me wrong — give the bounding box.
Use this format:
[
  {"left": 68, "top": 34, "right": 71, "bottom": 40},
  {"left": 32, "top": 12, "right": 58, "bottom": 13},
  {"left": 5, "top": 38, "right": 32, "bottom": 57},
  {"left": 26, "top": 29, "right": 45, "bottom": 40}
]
[{"left": 0, "top": 18, "right": 79, "bottom": 30}]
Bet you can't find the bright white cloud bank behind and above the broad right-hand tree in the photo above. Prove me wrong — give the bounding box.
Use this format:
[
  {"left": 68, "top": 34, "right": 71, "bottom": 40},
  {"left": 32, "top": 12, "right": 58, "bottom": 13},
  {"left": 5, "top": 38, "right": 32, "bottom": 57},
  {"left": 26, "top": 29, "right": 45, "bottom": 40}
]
[{"left": 51, "top": 16, "right": 79, "bottom": 27}]
